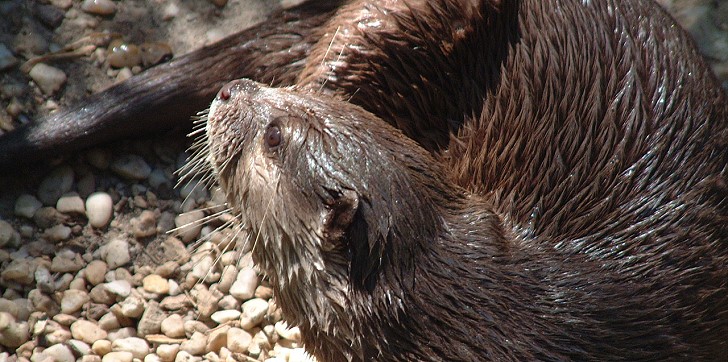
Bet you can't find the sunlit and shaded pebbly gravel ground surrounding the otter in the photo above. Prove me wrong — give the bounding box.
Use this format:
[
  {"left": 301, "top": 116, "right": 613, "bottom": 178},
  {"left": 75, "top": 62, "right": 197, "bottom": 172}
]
[{"left": 0, "top": 0, "right": 728, "bottom": 362}]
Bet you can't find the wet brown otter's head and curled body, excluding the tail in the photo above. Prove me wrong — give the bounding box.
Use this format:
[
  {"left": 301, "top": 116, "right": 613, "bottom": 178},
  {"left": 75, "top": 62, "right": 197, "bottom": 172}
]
[{"left": 199, "top": 1, "right": 728, "bottom": 361}]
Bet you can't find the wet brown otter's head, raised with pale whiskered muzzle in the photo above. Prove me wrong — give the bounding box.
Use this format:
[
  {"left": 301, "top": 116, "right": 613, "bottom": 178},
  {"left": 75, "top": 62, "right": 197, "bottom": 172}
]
[{"left": 206, "top": 80, "right": 448, "bottom": 356}]
